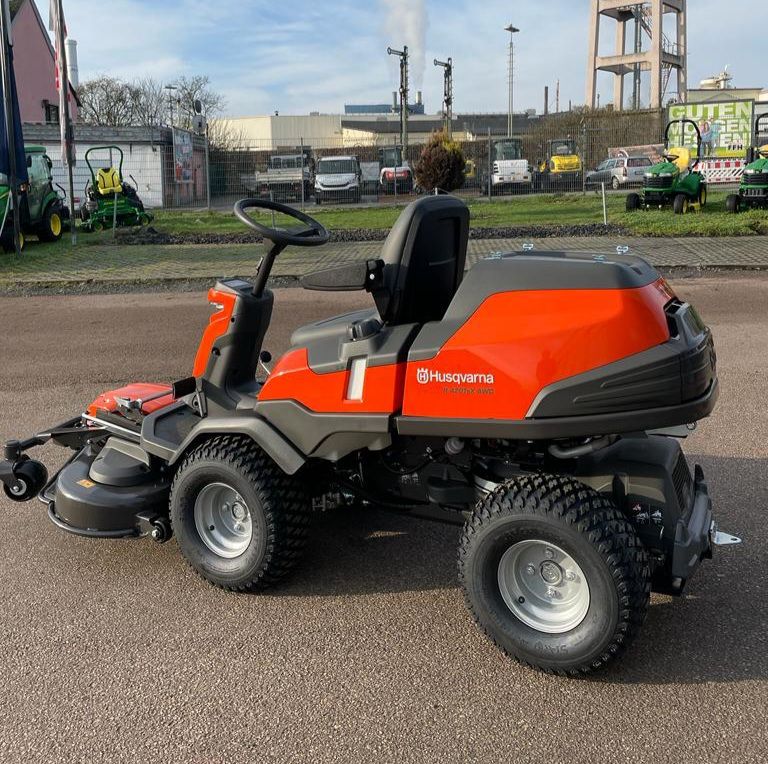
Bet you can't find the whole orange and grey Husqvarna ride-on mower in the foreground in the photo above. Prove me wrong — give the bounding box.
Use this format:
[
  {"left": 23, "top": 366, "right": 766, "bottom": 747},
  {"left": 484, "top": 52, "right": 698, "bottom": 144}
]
[{"left": 0, "top": 196, "right": 738, "bottom": 674}]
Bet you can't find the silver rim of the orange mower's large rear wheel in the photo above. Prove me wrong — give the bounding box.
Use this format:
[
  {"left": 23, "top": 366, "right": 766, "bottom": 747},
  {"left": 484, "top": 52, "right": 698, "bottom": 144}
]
[{"left": 498, "top": 539, "right": 589, "bottom": 634}]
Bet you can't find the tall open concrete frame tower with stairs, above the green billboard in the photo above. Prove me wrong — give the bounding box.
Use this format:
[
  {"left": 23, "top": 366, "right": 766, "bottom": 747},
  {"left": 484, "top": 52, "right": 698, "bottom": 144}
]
[{"left": 586, "top": 0, "right": 688, "bottom": 110}]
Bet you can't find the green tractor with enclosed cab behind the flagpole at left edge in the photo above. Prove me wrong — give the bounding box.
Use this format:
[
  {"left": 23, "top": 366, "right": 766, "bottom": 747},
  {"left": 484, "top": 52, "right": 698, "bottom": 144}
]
[{"left": 0, "top": 146, "right": 68, "bottom": 252}]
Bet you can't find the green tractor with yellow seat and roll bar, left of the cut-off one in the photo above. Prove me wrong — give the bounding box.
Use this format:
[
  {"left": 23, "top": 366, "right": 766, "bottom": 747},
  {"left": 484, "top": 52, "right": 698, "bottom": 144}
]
[{"left": 627, "top": 119, "right": 707, "bottom": 215}]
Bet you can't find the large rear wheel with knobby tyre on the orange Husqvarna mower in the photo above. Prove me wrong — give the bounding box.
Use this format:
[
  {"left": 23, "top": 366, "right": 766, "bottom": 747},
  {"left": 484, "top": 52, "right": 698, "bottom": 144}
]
[{"left": 459, "top": 475, "right": 650, "bottom": 675}]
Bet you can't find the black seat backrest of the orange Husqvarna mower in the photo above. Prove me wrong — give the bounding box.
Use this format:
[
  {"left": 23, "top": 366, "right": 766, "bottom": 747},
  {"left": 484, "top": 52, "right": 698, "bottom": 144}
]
[{"left": 372, "top": 195, "right": 469, "bottom": 325}]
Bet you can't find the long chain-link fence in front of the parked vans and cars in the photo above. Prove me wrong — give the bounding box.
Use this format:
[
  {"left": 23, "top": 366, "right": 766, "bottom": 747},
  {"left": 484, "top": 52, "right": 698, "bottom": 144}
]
[{"left": 25, "top": 111, "right": 744, "bottom": 215}]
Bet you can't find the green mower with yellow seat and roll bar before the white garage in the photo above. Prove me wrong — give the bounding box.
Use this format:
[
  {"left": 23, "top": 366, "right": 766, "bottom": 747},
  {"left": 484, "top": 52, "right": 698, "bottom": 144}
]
[{"left": 80, "top": 146, "right": 152, "bottom": 231}]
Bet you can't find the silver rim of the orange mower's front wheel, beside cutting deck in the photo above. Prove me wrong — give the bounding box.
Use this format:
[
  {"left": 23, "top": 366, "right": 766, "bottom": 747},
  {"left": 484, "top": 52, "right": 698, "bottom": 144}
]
[{"left": 195, "top": 483, "right": 253, "bottom": 559}]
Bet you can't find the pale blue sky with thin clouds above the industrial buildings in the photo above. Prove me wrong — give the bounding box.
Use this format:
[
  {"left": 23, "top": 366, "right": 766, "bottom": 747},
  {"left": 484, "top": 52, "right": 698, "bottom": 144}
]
[{"left": 35, "top": 0, "right": 768, "bottom": 116}]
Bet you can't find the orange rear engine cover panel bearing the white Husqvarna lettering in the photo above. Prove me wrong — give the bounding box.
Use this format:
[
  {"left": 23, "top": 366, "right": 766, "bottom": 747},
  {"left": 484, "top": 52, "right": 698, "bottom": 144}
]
[{"left": 403, "top": 280, "right": 670, "bottom": 420}]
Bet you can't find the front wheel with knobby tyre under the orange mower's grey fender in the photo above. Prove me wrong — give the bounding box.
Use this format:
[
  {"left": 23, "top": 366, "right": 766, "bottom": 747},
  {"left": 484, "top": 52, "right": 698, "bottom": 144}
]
[{"left": 170, "top": 436, "right": 311, "bottom": 591}]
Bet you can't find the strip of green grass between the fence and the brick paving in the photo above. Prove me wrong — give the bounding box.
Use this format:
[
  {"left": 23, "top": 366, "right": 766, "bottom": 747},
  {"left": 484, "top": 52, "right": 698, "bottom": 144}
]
[{"left": 153, "top": 191, "right": 768, "bottom": 236}]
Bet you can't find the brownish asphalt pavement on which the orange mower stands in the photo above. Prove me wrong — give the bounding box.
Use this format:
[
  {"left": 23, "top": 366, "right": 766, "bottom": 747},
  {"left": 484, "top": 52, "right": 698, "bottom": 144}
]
[{"left": 0, "top": 275, "right": 768, "bottom": 764}]
